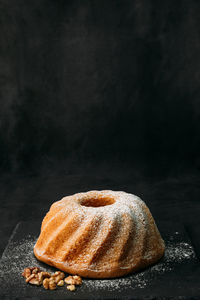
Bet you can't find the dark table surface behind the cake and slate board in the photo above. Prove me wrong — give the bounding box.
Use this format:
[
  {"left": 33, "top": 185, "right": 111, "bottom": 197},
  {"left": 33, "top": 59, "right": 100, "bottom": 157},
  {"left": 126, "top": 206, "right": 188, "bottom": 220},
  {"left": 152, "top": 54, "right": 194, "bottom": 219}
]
[{"left": 0, "top": 166, "right": 200, "bottom": 298}]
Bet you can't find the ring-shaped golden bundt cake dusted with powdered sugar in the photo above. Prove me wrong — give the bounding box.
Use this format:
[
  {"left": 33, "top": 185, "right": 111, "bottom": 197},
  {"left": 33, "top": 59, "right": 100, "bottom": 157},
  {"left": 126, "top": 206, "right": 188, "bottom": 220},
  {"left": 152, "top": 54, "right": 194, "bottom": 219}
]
[{"left": 34, "top": 190, "right": 165, "bottom": 278}]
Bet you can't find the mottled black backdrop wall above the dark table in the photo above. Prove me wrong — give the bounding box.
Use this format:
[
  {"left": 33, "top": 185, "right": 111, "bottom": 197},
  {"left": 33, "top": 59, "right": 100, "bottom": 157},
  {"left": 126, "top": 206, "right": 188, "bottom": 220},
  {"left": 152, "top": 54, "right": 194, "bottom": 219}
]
[{"left": 0, "top": 0, "right": 200, "bottom": 174}]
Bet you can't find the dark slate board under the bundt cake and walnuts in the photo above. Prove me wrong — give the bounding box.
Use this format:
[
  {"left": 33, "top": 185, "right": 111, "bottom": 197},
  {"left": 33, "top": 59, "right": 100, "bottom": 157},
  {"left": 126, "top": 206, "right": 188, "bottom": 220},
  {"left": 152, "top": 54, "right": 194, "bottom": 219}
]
[{"left": 0, "top": 218, "right": 200, "bottom": 299}]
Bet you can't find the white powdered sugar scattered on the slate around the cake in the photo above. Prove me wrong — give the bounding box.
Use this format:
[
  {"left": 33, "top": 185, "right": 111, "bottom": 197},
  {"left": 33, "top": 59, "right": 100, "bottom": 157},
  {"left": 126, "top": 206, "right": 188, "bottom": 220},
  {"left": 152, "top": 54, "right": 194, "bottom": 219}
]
[{"left": 0, "top": 233, "right": 196, "bottom": 293}]
